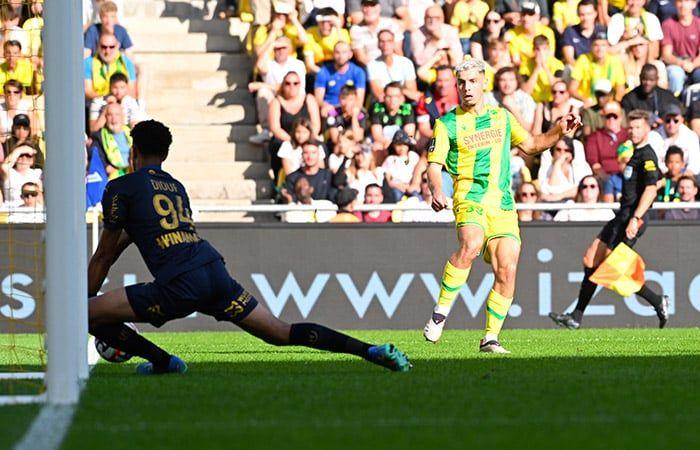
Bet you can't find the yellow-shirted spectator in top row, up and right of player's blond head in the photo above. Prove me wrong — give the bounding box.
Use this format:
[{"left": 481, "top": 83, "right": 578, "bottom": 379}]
[{"left": 505, "top": 1, "right": 556, "bottom": 66}]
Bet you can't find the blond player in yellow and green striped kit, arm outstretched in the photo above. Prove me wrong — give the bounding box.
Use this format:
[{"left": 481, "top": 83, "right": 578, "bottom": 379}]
[{"left": 423, "top": 59, "right": 581, "bottom": 353}]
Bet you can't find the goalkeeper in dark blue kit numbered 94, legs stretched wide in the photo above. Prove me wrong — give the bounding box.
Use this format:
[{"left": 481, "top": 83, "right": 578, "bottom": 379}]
[{"left": 88, "top": 120, "right": 411, "bottom": 374}]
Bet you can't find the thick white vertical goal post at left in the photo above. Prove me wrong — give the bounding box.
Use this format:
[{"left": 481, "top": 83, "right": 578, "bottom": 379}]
[{"left": 43, "top": 0, "right": 89, "bottom": 404}]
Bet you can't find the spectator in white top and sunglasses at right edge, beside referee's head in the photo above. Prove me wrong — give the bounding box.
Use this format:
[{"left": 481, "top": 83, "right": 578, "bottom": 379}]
[{"left": 650, "top": 103, "right": 700, "bottom": 175}]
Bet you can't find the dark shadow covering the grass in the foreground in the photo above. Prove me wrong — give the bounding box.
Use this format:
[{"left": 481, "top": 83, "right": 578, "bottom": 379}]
[{"left": 56, "top": 354, "right": 700, "bottom": 449}]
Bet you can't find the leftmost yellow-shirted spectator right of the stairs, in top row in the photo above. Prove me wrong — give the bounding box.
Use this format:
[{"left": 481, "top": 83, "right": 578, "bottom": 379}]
[{"left": 253, "top": 1, "right": 308, "bottom": 64}]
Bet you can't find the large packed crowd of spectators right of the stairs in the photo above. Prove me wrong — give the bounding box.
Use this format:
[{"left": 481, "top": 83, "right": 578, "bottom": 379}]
[{"left": 240, "top": 0, "right": 700, "bottom": 222}]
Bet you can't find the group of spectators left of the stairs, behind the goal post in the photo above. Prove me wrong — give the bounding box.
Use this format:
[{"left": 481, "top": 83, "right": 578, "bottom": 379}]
[{"left": 0, "top": 0, "right": 145, "bottom": 221}]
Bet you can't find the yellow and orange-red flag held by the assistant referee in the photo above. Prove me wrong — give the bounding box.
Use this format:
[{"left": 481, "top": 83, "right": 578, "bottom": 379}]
[{"left": 591, "top": 243, "right": 646, "bottom": 297}]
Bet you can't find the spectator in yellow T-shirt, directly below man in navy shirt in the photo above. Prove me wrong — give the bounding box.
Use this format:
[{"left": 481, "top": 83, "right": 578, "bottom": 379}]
[{"left": 569, "top": 31, "right": 625, "bottom": 108}]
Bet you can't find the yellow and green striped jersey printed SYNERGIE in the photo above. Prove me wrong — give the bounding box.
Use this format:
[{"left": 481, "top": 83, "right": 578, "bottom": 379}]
[{"left": 428, "top": 106, "right": 529, "bottom": 211}]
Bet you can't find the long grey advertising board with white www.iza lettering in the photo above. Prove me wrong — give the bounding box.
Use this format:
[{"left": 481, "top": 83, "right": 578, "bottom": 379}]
[{"left": 0, "top": 223, "right": 700, "bottom": 331}]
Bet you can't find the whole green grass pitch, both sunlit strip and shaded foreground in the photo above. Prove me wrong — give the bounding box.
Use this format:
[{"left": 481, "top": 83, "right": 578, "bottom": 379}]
[{"left": 0, "top": 329, "right": 700, "bottom": 450}]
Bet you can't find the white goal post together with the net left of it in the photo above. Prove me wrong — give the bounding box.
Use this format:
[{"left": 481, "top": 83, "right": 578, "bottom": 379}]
[{"left": 0, "top": 0, "right": 87, "bottom": 405}]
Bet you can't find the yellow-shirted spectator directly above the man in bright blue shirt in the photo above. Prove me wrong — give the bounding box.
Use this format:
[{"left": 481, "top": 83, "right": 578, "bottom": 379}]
[{"left": 304, "top": 8, "right": 350, "bottom": 73}]
